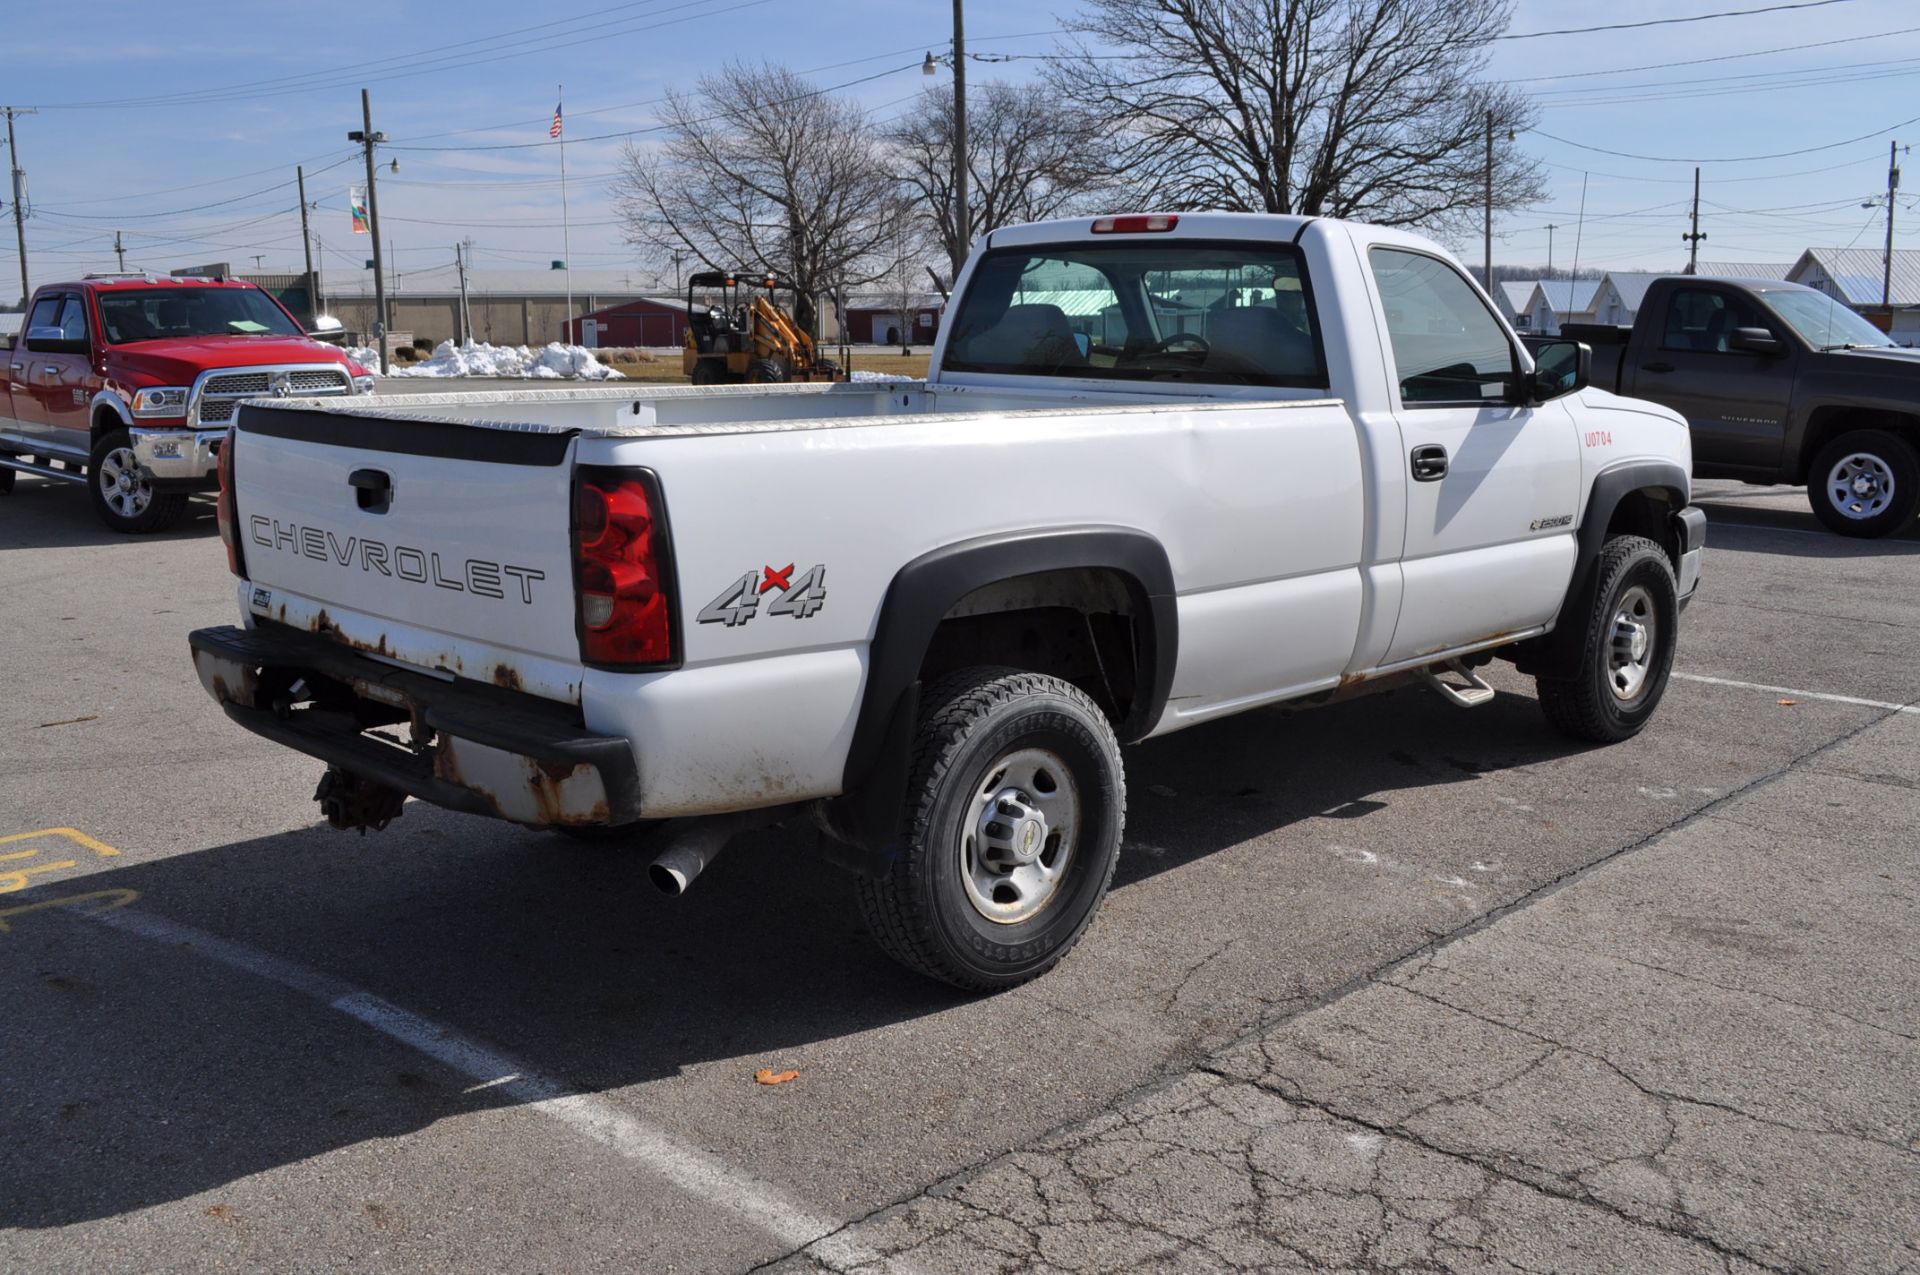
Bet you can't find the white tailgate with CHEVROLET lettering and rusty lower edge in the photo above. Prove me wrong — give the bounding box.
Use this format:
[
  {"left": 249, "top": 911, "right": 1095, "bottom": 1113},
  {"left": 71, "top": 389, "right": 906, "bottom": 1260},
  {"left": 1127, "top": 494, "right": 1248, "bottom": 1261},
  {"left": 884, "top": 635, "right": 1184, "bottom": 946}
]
[{"left": 234, "top": 405, "right": 582, "bottom": 703}]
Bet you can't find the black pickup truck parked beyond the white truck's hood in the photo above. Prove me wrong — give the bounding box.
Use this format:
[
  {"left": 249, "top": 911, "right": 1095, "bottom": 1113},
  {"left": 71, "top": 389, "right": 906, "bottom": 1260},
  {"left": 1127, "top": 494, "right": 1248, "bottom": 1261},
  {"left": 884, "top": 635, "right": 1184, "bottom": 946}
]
[{"left": 1528, "top": 275, "right": 1920, "bottom": 536}]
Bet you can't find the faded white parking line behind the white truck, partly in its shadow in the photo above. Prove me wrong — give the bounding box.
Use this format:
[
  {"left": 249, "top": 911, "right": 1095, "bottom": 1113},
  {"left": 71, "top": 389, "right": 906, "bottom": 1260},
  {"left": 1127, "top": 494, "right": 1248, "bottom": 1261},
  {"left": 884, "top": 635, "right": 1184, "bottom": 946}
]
[{"left": 88, "top": 908, "right": 900, "bottom": 1271}]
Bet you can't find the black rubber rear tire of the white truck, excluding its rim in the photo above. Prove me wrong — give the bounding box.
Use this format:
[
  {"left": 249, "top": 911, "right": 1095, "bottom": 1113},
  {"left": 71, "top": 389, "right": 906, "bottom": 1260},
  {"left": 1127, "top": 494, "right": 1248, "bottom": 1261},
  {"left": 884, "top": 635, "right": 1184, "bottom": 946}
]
[{"left": 858, "top": 668, "right": 1127, "bottom": 993}]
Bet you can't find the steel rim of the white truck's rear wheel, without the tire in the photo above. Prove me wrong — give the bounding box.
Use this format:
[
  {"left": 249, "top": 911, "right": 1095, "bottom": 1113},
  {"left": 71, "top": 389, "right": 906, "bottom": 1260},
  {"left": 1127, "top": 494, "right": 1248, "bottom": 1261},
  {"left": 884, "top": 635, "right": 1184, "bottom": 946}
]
[{"left": 960, "top": 749, "right": 1081, "bottom": 926}]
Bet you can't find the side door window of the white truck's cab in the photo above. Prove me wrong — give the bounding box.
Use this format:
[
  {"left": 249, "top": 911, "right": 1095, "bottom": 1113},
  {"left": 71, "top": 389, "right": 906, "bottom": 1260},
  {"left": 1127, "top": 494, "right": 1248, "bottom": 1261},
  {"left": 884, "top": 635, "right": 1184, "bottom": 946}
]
[{"left": 1367, "top": 248, "right": 1517, "bottom": 405}]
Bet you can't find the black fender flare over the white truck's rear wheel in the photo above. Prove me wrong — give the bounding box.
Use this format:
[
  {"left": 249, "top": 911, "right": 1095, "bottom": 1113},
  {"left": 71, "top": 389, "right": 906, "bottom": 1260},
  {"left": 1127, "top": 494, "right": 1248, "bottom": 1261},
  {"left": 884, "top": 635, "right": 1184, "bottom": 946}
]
[{"left": 828, "top": 524, "right": 1179, "bottom": 870}]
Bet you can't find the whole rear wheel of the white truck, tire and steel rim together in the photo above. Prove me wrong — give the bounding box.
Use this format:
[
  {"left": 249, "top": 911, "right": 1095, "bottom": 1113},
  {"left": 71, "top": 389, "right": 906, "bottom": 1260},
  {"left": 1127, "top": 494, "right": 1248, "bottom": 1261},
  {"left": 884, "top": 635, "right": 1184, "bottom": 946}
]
[{"left": 858, "top": 668, "right": 1127, "bottom": 991}]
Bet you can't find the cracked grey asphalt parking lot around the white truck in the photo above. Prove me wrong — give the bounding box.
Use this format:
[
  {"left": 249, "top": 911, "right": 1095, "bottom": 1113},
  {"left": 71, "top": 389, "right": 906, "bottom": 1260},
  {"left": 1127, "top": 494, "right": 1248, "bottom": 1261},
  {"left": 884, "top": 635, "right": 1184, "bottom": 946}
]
[{"left": 0, "top": 460, "right": 1920, "bottom": 1271}]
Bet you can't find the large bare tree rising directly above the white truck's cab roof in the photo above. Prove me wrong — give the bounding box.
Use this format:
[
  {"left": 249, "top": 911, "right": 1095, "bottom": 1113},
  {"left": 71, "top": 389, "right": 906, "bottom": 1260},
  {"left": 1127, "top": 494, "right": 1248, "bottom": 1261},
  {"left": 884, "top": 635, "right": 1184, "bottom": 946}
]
[{"left": 1052, "top": 0, "right": 1544, "bottom": 227}]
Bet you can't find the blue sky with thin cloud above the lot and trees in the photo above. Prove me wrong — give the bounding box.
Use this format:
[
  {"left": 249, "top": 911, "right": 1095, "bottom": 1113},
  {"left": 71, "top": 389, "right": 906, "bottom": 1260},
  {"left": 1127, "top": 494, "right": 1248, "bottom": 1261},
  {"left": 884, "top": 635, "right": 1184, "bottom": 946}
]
[{"left": 0, "top": 0, "right": 1920, "bottom": 296}]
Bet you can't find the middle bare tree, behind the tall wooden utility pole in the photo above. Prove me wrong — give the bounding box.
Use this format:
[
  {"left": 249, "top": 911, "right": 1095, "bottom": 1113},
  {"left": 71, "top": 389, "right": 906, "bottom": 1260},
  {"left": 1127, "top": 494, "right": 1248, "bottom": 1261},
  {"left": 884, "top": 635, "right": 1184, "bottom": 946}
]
[{"left": 887, "top": 83, "right": 1114, "bottom": 275}]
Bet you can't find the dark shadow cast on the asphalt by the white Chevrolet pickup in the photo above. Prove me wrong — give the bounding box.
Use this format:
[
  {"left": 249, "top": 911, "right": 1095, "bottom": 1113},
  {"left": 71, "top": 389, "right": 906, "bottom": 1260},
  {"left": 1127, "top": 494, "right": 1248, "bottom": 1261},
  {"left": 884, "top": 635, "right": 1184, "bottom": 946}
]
[{"left": 0, "top": 675, "right": 1576, "bottom": 1229}]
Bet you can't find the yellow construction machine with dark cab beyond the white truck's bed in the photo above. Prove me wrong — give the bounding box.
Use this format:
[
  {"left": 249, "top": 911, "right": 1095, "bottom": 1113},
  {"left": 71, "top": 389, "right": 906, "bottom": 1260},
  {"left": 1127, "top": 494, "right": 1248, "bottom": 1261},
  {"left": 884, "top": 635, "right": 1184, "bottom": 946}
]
[{"left": 680, "top": 271, "right": 847, "bottom": 386}]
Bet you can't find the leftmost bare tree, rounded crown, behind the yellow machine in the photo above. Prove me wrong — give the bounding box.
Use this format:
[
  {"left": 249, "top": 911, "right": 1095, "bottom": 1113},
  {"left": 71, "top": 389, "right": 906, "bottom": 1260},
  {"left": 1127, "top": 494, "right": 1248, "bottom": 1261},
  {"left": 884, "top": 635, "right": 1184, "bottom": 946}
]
[{"left": 614, "top": 61, "right": 900, "bottom": 332}]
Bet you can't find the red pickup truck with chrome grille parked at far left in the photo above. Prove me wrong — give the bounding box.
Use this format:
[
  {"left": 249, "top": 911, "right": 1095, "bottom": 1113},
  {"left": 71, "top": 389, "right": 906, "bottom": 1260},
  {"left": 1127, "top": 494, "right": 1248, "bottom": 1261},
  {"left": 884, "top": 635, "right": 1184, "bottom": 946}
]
[{"left": 0, "top": 275, "right": 372, "bottom": 532}]
